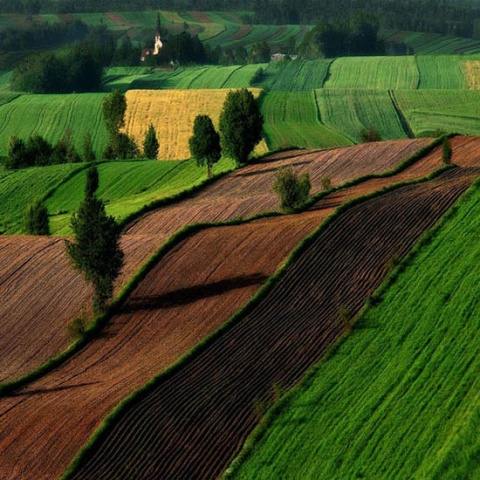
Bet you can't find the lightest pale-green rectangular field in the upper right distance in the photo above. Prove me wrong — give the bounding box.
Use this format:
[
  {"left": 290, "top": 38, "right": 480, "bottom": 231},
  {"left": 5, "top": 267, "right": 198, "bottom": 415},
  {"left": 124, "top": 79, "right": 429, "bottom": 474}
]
[{"left": 325, "top": 56, "right": 419, "bottom": 90}]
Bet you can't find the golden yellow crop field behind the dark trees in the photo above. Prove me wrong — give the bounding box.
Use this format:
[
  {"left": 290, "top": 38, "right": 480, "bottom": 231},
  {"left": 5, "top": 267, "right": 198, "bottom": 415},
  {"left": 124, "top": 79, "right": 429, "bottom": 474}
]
[{"left": 125, "top": 88, "right": 268, "bottom": 160}]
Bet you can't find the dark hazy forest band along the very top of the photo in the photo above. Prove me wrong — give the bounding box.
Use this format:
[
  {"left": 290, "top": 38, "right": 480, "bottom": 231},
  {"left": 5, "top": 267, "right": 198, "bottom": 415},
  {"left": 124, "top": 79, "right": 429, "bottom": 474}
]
[{"left": 0, "top": 0, "right": 480, "bottom": 37}]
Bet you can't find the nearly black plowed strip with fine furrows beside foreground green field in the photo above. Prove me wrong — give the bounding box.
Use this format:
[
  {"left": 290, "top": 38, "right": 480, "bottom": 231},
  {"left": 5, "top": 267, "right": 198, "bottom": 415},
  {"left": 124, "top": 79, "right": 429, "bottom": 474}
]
[{"left": 65, "top": 167, "right": 480, "bottom": 479}]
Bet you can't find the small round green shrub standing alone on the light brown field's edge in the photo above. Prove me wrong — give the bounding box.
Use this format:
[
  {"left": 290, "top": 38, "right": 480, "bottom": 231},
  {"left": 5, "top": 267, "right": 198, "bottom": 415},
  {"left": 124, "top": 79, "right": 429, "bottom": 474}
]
[{"left": 273, "top": 167, "right": 312, "bottom": 210}]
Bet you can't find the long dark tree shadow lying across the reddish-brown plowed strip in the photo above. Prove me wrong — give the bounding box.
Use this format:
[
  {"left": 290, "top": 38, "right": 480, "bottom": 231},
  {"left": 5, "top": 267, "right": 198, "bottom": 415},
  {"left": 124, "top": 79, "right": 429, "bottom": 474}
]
[{"left": 121, "top": 273, "right": 268, "bottom": 313}]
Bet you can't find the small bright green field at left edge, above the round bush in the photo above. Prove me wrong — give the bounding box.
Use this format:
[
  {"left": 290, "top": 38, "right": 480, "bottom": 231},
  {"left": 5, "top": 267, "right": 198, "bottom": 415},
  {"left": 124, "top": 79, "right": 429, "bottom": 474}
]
[{"left": 0, "top": 164, "right": 83, "bottom": 234}]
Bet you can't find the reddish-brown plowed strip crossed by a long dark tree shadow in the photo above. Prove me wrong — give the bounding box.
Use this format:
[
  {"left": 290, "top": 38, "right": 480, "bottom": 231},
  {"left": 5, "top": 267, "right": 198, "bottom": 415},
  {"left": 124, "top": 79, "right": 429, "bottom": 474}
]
[{"left": 0, "top": 140, "right": 458, "bottom": 479}]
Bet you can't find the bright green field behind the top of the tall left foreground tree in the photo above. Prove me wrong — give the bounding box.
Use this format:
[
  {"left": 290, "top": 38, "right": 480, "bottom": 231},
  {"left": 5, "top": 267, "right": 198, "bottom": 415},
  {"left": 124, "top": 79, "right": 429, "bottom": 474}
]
[{"left": 46, "top": 159, "right": 234, "bottom": 235}]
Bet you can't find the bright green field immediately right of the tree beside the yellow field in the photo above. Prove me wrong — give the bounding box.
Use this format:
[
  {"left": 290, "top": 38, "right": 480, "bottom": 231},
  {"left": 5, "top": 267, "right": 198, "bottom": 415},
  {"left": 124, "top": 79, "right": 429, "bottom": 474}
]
[{"left": 262, "top": 91, "right": 352, "bottom": 149}]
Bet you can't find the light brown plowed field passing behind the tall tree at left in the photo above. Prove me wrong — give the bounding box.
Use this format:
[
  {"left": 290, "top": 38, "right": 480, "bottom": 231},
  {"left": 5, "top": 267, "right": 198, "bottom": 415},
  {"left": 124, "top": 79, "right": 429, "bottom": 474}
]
[{"left": 0, "top": 139, "right": 436, "bottom": 381}]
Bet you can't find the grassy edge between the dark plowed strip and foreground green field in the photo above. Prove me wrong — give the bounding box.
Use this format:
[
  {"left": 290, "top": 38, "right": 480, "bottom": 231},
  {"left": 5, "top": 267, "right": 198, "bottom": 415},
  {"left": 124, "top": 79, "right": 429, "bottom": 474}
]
[{"left": 224, "top": 171, "right": 480, "bottom": 480}]
